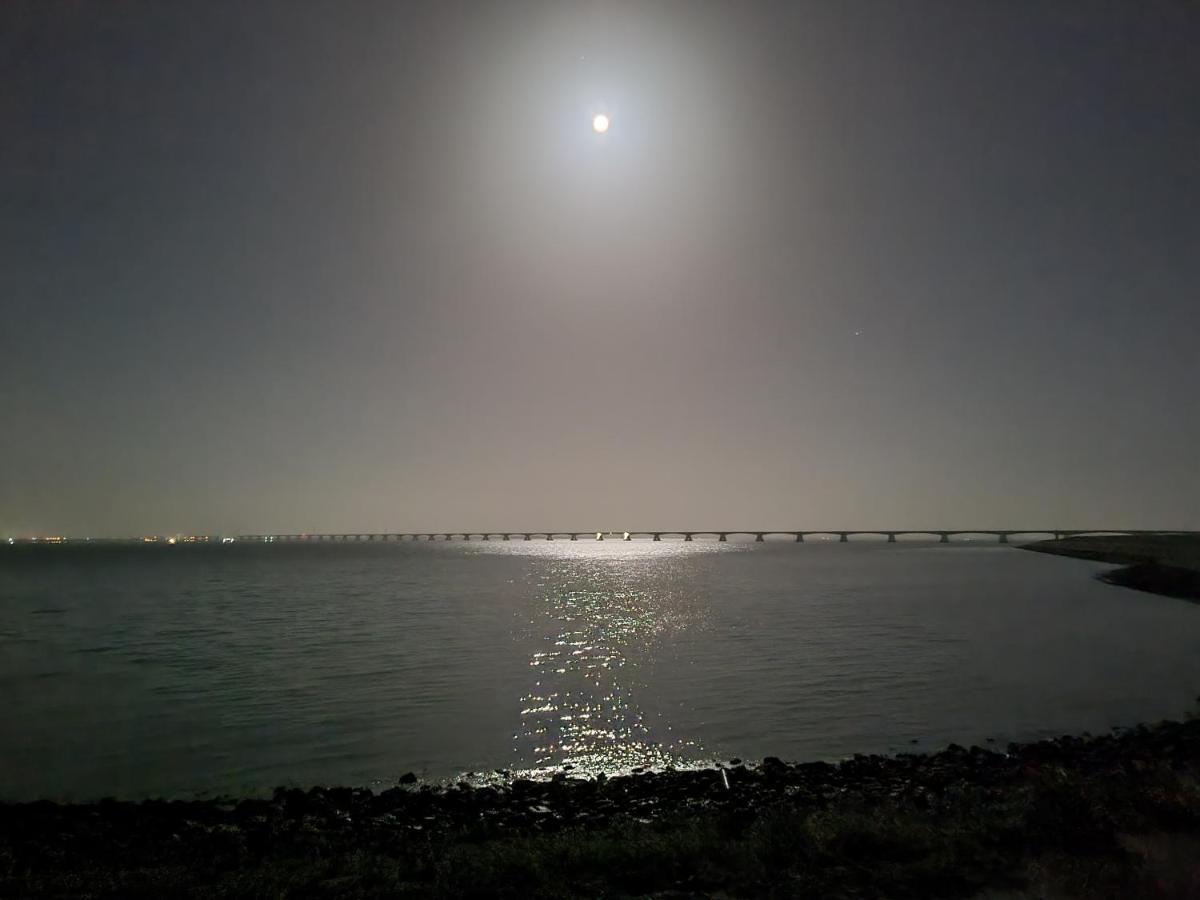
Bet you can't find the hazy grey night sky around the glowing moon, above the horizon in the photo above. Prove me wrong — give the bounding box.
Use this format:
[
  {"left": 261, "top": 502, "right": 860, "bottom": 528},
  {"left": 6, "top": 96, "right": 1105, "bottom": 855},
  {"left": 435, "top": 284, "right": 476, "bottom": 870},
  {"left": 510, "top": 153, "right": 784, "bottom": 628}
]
[{"left": 0, "top": 0, "right": 1200, "bottom": 535}]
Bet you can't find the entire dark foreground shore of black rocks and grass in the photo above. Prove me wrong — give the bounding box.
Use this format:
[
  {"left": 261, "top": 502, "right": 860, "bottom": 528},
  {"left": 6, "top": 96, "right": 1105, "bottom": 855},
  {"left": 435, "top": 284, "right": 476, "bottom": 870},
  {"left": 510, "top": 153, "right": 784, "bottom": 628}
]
[{"left": 7, "top": 721, "right": 1200, "bottom": 898}]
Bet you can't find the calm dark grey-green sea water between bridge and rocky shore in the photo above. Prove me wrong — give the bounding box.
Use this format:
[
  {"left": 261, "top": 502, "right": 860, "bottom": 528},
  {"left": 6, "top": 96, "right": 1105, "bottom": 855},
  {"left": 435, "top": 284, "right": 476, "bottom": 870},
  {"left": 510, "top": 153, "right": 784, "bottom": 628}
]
[{"left": 0, "top": 541, "right": 1200, "bottom": 799}]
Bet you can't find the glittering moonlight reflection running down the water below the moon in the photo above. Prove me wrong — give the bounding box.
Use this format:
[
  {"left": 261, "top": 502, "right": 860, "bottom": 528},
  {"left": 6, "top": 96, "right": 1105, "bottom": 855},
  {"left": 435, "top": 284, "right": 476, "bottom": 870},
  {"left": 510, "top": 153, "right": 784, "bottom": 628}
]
[{"left": 482, "top": 541, "right": 737, "bottom": 774}]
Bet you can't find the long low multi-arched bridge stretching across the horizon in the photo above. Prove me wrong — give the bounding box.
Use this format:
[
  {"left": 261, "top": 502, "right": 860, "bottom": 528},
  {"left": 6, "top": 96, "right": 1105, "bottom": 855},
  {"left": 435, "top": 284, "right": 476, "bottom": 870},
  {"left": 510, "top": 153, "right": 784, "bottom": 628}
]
[{"left": 229, "top": 528, "right": 1194, "bottom": 544}]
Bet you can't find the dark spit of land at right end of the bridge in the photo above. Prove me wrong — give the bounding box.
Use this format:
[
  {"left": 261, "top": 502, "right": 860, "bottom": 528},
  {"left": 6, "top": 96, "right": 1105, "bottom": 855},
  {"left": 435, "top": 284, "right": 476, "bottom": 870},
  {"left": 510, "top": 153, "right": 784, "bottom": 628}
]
[{"left": 1022, "top": 534, "right": 1200, "bottom": 600}]
